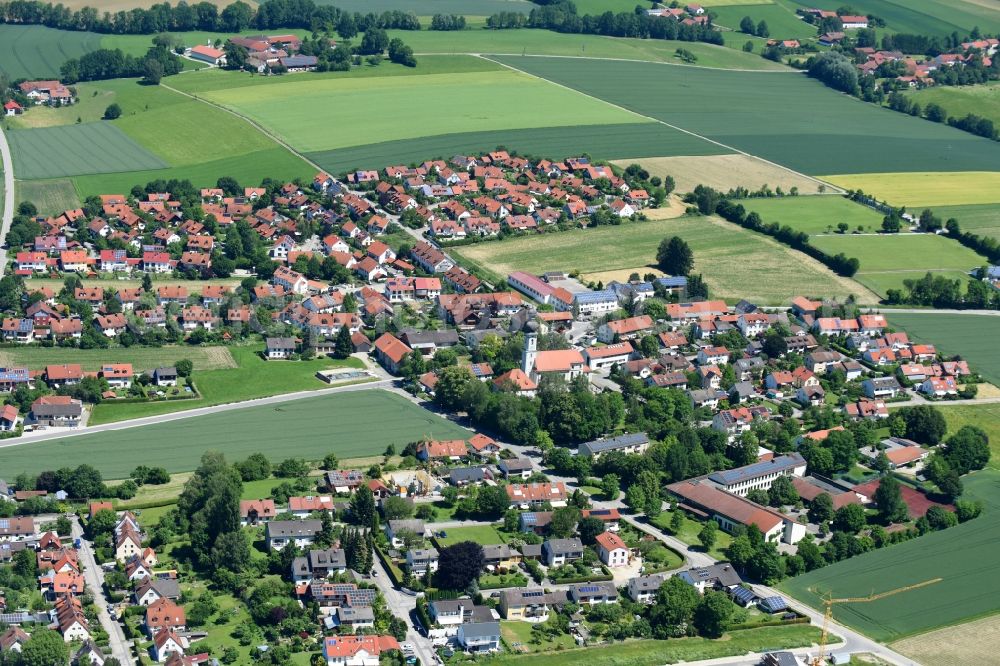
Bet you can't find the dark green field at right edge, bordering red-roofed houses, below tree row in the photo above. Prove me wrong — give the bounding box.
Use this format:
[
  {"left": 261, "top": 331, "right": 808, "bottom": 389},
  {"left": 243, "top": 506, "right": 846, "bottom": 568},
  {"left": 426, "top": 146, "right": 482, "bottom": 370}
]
[{"left": 887, "top": 311, "right": 1000, "bottom": 384}]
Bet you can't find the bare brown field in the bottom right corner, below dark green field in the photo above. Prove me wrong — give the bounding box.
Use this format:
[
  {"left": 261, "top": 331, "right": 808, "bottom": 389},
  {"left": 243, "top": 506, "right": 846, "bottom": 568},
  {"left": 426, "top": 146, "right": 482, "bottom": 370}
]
[{"left": 891, "top": 615, "right": 1000, "bottom": 666}]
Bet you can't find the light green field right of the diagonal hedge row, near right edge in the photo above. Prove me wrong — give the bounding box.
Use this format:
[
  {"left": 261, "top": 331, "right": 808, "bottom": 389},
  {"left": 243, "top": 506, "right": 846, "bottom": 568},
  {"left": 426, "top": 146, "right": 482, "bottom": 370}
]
[{"left": 810, "top": 234, "right": 986, "bottom": 296}]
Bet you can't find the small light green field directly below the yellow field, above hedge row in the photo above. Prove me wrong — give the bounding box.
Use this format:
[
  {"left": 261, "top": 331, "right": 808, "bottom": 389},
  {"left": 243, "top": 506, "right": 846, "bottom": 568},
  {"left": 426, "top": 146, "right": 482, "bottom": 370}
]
[{"left": 740, "top": 195, "right": 883, "bottom": 235}]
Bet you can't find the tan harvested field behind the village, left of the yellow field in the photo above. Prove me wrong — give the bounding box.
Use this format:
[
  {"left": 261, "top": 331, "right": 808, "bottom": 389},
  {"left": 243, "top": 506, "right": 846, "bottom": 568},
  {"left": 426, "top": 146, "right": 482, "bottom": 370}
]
[{"left": 614, "top": 154, "right": 834, "bottom": 194}]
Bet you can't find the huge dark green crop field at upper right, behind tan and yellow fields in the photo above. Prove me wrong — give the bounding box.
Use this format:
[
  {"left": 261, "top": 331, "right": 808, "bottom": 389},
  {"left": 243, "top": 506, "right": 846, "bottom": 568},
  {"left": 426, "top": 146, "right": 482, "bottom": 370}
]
[{"left": 495, "top": 56, "right": 1000, "bottom": 174}]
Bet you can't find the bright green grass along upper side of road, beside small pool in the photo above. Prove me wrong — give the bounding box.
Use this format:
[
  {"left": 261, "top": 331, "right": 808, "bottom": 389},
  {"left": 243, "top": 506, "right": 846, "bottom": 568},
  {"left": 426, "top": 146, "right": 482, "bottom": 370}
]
[{"left": 90, "top": 344, "right": 363, "bottom": 425}]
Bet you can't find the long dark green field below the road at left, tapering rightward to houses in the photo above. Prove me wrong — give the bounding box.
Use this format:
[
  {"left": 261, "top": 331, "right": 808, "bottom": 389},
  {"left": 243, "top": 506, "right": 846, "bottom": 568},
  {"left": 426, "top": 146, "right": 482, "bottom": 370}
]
[{"left": 0, "top": 386, "right": 469, "bottom": 478}]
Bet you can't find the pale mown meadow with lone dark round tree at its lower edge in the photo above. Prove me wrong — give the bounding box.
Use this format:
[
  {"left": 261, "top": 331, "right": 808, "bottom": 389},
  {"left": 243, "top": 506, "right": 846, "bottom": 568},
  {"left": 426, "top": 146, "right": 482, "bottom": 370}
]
[{"left": 451, "top": 217, "right": 877, "bottom": 305}]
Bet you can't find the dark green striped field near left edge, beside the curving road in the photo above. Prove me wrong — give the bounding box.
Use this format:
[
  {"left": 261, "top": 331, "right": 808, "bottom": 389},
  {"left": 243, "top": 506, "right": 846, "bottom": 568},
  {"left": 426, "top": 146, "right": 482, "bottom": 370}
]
[{"left": 8, "top": 122, "right": 167, "bottom": 179}]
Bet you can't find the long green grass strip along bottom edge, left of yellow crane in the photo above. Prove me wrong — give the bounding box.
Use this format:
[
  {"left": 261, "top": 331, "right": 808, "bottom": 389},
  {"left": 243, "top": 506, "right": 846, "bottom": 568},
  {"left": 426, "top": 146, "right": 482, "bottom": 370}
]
[{"left": 490, "top": 623, "right": 820, "bottom": 666}]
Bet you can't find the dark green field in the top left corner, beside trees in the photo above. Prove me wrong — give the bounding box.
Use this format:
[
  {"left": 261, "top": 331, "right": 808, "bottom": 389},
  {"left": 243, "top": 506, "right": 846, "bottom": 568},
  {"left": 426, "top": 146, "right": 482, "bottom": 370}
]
[{"left": 0, "top": 25, "right": 101, "bottom": 80}]
